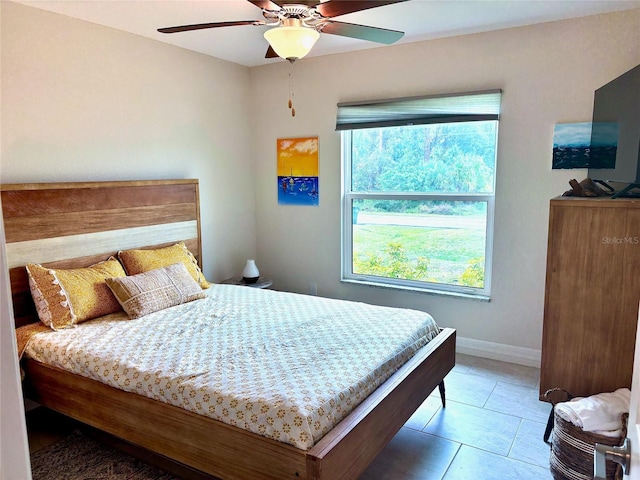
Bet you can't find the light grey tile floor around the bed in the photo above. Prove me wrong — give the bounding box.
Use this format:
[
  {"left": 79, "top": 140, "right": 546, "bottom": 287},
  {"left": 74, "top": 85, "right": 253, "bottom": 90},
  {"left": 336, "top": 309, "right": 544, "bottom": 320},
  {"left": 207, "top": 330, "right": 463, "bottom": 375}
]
[{"left": 27, "top": 355, "right": 552, "bottom": 480}]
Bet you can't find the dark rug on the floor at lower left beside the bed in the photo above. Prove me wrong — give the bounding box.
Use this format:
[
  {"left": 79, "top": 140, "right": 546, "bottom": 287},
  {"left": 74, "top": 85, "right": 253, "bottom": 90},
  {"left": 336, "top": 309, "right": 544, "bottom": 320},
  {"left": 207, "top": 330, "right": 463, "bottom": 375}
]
[{"left": 31, "top": 430, "right": 180, "bottom": 480}]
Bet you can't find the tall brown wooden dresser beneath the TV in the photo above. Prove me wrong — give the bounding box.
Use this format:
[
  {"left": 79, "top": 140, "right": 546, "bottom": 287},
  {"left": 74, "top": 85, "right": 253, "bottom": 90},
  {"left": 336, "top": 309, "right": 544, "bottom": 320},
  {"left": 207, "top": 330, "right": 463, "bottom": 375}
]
[{"left": 540, "top": 197, "right": 640, "bottom": 399}]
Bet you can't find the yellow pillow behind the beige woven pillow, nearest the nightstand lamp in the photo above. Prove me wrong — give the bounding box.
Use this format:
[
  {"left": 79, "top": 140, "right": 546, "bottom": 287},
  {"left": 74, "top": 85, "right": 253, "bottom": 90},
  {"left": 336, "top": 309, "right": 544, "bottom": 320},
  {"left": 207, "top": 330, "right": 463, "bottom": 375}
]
[{"left": 118, "top": 242, "right": 210, "bottom": 288}]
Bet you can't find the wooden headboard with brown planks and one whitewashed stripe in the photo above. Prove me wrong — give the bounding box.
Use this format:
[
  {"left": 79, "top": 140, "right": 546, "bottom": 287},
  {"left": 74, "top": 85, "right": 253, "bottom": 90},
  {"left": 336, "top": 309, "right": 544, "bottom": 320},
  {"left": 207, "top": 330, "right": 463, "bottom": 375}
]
[{"left": 0, "top": 179, "right": 202, "bottom": 327}]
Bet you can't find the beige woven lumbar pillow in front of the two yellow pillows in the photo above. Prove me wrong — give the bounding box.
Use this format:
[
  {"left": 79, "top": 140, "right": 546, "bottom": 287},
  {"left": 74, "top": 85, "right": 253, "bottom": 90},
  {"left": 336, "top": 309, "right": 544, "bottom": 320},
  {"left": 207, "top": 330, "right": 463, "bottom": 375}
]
[{"left": 107, "top": 263, "right": 205, "bottom": 318}]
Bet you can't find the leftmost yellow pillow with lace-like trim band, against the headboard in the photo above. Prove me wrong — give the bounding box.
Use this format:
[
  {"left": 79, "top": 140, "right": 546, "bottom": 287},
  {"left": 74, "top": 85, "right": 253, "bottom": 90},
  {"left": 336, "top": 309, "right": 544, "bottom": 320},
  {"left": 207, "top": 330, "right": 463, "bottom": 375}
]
[{"left": 26, "top": 257, "right": 126, "bottom": 330}]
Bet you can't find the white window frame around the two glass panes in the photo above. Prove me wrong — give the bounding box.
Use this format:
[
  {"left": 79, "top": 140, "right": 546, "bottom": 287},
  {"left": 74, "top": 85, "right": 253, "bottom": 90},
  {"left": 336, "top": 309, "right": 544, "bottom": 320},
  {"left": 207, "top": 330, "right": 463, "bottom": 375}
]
[{"left": 340, "top": 124, "right": 499, "bottom": 301}]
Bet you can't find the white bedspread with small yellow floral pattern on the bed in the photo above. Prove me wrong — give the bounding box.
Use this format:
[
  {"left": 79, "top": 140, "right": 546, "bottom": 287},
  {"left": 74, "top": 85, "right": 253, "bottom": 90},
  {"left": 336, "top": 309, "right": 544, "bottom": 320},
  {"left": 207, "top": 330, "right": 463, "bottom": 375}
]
[{"left": 25, "top": 285, "right": 438, "bottom": 450}]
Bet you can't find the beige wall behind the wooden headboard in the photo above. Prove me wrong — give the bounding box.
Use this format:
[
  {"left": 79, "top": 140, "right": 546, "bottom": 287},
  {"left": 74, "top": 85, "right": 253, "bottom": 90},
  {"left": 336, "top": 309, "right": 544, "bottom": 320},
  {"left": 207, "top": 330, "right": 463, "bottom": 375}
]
[{"left": 0, "top": 1, "right": 255, "bottom": 280}]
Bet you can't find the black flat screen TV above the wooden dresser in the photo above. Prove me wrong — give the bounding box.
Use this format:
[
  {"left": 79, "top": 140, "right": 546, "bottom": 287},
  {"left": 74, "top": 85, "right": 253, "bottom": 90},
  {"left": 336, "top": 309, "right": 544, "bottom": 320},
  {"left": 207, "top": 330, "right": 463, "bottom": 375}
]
[{"left": 588, "top": 65, "right": 640, "bottom": 197}]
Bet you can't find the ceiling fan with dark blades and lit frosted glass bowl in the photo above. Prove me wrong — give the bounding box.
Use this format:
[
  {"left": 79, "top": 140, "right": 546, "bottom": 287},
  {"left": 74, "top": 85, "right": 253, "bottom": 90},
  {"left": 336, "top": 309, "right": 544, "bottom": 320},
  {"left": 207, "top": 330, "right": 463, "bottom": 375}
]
[{"left": 158, "top": 0, "right": 407, "bottom": 62}]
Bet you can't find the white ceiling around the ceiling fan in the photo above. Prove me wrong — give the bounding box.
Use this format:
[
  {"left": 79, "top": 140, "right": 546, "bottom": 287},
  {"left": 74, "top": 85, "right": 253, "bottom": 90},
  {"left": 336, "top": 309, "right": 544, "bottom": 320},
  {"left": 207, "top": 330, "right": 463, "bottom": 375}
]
[{"left": 18, "top": 0, "right": 640, "bottom": 67}]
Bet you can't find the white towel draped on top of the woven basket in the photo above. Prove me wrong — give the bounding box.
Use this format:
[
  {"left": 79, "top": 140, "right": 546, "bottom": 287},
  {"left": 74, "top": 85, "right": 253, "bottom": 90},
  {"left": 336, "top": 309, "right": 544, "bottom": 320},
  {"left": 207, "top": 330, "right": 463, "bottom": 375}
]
[{"left": 555, "top": 388, "right": 631, "bottom": 437}]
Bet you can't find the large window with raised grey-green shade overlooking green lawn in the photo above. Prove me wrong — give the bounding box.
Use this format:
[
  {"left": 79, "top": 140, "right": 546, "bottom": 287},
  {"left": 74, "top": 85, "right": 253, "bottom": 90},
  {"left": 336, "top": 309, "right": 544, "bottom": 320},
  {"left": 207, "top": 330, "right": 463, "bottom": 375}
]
[{"left": 337, "top": 91, "right": 500, "bottom": 299}]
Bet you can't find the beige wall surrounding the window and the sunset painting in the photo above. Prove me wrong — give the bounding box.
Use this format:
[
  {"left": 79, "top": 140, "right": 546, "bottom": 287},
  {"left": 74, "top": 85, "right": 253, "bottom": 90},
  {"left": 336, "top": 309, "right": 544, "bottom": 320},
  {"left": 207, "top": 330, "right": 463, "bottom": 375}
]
[{"left": 251, "top": 10, "right": 640, "bottom": 364}]
